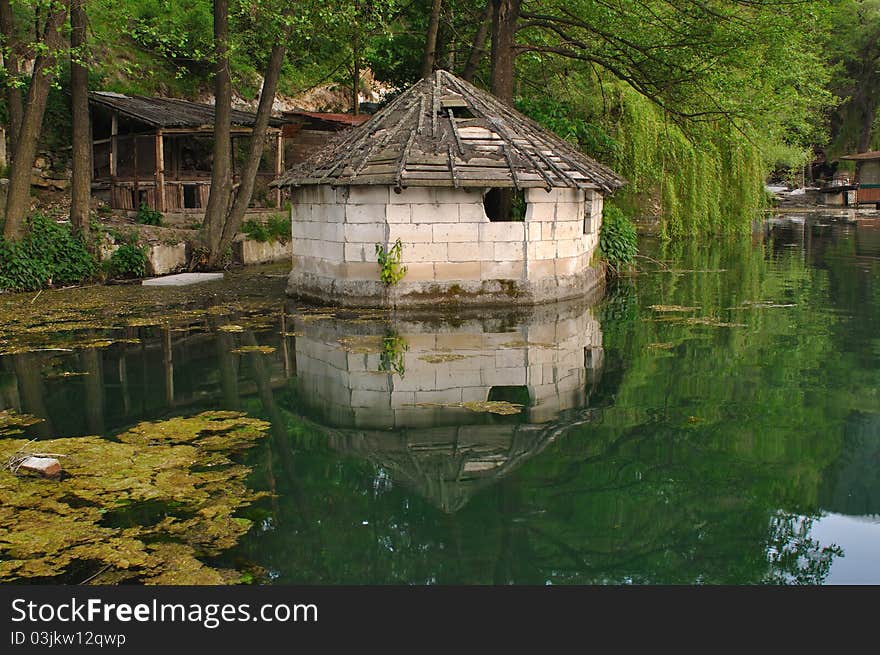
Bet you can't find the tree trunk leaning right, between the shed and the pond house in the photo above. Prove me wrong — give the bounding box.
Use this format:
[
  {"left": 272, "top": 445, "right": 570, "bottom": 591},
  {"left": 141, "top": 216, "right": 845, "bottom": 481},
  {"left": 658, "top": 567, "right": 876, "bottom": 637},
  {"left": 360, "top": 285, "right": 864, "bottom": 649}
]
[{"left": 208, "top": 38, "right": 290, "bottom": 266}]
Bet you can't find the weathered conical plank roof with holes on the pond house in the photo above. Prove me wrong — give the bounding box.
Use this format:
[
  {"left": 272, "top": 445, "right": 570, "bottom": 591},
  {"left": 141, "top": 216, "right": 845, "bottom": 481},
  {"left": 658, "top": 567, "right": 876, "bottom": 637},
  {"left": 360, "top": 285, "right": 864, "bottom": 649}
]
[{"left": 274, "top": 70, "right": 625, "bottom": 192}]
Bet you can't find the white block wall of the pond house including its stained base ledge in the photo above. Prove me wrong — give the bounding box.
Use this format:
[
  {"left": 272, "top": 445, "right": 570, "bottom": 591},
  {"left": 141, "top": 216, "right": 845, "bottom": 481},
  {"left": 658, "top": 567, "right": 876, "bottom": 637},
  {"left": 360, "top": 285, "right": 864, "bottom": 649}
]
[{"left": 288, "top": 186, "right": 602, "bottom": 306}]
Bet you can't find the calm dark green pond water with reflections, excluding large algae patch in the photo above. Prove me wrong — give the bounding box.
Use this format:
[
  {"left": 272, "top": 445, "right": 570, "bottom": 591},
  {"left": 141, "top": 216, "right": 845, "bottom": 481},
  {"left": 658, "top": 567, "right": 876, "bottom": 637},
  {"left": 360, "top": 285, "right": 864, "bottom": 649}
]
[{"left": 0, "top": 217, "right": 880, "bottom": 584}]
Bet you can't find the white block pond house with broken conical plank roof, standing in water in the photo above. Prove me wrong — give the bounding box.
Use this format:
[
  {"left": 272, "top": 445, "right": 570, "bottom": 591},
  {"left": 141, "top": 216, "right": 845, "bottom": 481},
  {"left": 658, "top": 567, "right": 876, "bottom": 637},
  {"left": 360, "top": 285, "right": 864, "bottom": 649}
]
[{"left": 277, "top": 71, "right": 624, "bottom": 307}]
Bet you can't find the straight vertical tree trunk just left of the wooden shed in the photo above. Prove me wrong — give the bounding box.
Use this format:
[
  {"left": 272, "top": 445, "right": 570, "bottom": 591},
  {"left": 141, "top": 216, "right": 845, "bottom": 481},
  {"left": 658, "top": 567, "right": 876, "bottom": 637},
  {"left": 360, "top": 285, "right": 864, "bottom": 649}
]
[{"left": 70, "top": 0, "right": 92, "bottom": 243}]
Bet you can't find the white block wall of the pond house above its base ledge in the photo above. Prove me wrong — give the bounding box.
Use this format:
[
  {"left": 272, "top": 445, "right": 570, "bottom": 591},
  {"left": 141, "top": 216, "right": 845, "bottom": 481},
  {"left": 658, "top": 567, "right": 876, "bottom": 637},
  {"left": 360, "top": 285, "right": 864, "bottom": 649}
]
[{"left": 292, "top": 186, "right": 602, "bottom": 282}]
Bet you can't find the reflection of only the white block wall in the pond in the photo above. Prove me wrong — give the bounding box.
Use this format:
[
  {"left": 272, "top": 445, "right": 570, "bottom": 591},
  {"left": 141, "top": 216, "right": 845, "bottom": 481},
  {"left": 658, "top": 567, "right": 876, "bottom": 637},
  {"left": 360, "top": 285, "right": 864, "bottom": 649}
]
[{"left": 294, "top": 307, "right": 603, "bottom": 430}]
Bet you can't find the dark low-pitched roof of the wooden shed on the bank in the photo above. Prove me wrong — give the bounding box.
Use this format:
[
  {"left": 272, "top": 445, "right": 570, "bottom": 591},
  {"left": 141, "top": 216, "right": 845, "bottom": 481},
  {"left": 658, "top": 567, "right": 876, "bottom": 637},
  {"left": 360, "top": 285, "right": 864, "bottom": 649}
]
[{"left": 89, "top": 91, "right": 279, "bottom": 129}]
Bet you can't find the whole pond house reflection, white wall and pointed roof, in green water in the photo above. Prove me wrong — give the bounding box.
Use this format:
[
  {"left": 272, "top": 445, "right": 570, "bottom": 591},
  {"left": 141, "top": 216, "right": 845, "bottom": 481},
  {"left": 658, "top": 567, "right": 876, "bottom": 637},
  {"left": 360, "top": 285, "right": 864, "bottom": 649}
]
[{"left": 295, "top": 304, "right": 603, "bottom": 512}]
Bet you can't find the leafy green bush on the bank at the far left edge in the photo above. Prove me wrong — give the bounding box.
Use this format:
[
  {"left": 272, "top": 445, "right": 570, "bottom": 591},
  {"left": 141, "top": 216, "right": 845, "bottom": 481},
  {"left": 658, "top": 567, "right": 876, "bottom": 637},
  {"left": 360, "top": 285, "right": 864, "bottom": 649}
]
[{"left": 0, "top": 214, "right": 96, "bottom": 291}]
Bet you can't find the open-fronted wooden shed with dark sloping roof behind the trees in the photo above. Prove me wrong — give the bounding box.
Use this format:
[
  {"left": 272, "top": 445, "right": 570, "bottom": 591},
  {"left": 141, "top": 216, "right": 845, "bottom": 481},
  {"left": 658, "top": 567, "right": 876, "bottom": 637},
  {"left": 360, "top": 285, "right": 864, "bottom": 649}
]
[{"left": 89, "top": 91, "right": 284, "bottom": 212}]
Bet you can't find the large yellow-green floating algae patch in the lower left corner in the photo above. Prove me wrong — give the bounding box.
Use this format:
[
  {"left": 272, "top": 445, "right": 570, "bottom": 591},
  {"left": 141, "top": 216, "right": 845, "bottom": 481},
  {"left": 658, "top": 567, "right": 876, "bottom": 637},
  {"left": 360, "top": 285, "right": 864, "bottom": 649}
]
[{"left": 0, "top": 412, "right": 269, "bottom": 584}]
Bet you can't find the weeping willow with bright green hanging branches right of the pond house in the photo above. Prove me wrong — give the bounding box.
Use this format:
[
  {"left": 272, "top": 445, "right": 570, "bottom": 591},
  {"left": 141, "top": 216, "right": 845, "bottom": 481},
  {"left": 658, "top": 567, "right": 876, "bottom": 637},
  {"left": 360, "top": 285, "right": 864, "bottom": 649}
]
[{"left": 506, "top": 0, "right": 832, "bottom": 238}]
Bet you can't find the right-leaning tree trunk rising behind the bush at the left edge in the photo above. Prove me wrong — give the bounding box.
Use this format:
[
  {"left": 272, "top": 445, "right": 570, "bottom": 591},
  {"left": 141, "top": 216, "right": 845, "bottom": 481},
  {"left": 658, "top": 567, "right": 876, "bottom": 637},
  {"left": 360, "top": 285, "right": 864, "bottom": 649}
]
[{"left": 3, "top": 3, "right": 67, "bottom": 240}]
